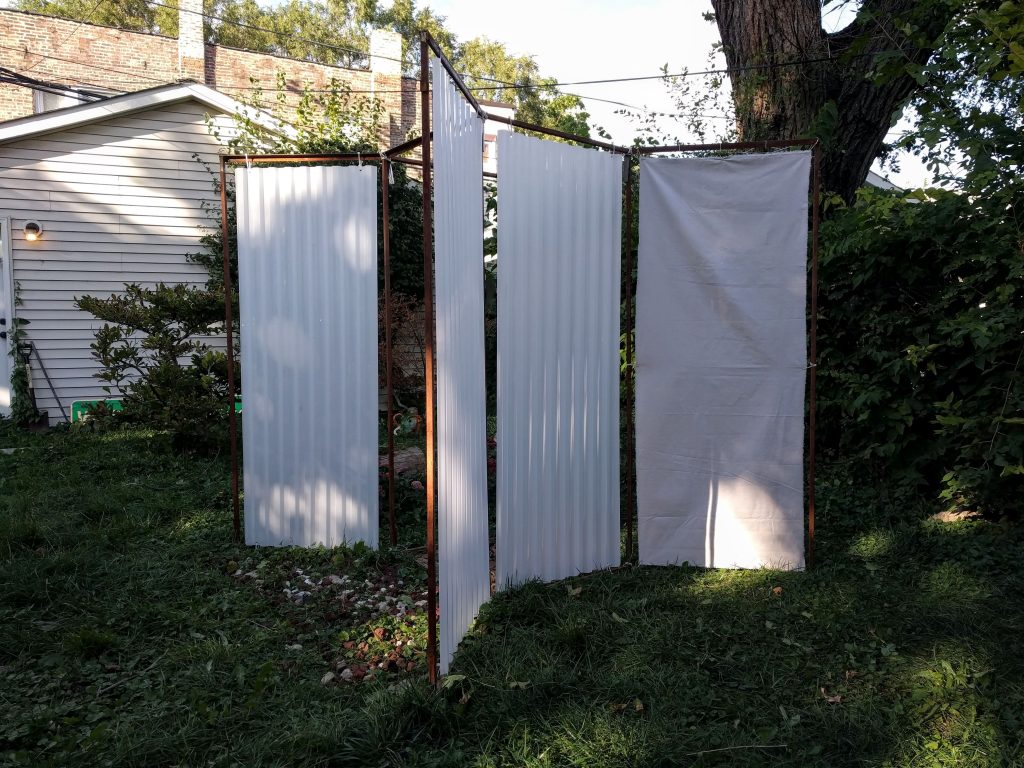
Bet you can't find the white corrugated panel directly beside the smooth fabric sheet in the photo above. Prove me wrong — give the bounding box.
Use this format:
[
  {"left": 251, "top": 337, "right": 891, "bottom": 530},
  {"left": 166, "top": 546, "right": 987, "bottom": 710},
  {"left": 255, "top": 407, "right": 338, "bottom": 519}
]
[{"left": 498, "top": 133, "right": 623, "bottom": 586}]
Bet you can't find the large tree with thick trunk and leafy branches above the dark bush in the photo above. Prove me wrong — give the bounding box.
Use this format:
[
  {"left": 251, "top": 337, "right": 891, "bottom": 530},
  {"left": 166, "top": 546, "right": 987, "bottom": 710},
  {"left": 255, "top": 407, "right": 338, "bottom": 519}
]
[{"left": 713, "top": 0, "right": 1024, "bottom": 202}]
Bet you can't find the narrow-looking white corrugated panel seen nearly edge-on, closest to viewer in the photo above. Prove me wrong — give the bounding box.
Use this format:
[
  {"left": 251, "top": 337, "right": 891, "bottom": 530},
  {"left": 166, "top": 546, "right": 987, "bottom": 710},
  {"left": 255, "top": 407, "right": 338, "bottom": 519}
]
[{"left": 432, "top": 60, "right": 490, "bottom": 675}]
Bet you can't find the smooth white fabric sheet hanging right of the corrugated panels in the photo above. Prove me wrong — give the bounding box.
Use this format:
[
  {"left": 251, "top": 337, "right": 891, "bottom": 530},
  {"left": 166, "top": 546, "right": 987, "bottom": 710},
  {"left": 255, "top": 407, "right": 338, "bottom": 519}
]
[{"left": 636, "top": 152, "right": 810, "bottom": 568}]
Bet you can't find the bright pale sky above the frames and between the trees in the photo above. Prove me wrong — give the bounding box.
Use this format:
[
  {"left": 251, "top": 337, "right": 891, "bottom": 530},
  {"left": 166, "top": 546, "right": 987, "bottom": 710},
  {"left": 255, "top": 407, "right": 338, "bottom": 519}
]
[{"left": 423, "top": 0, "right": 930, "bottom": 187}]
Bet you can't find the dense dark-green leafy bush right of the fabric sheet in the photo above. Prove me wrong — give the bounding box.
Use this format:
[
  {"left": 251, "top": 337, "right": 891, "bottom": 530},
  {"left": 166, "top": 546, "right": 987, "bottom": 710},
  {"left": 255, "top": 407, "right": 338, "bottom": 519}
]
[{"left": 819, "top": 183, "right": 1024, "bottom": 515}]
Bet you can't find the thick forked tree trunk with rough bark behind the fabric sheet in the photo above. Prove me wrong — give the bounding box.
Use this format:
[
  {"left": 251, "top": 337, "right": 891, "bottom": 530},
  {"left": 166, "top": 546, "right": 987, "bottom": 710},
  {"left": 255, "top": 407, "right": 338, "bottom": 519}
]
[{"left": 712, "top": 0, "right": 951, "bottom": 202}]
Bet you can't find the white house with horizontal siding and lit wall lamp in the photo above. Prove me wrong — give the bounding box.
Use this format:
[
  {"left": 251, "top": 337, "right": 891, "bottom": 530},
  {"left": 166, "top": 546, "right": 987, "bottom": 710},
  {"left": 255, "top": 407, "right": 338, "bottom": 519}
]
[{"left": 0, "top": 84, "right": 280, "bottom": 422}]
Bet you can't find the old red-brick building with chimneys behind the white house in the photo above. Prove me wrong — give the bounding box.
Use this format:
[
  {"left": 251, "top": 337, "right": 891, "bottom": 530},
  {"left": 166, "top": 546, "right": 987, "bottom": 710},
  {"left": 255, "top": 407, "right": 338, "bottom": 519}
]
[{"left": 0, "top": 0, "right": 419, "bottom": 145}]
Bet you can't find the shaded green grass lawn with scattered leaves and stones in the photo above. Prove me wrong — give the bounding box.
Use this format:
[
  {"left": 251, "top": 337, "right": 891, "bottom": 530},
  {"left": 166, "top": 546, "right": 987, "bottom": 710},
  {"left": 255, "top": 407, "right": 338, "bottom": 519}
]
[{"left": 0, "top": 424, "right": 1024, "bottom": 767}]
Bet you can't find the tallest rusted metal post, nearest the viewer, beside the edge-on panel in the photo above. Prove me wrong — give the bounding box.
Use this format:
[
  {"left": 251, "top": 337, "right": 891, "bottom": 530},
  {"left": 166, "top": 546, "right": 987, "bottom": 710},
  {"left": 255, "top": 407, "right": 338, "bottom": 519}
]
[{"left": 420, "top": 32, "right": 437, "bottom": 685}]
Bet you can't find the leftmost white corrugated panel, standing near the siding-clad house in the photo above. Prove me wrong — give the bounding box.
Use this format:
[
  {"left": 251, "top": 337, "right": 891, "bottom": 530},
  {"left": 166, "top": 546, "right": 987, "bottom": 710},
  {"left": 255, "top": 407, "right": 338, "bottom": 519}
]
[{"left": 236, "top": 166, "right": 378, "bottom": 548}]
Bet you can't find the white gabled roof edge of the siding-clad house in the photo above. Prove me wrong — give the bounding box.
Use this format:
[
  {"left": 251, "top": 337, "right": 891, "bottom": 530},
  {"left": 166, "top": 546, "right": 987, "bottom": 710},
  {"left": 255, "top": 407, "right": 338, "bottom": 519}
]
[{"left": 0, "top": 82, "right": 293, "bottom": 144}]
